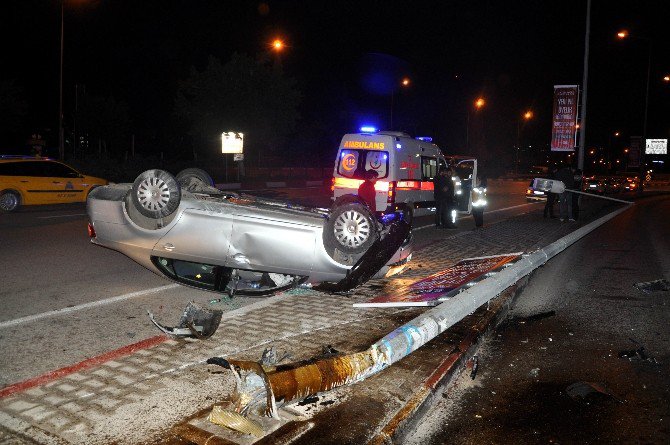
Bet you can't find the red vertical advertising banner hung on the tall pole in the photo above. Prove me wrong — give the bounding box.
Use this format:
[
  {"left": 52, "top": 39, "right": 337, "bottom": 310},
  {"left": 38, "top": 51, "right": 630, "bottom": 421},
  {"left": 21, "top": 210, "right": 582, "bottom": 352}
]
[{"left": 551, "top": 85, "right": 579, "bottom": 151}]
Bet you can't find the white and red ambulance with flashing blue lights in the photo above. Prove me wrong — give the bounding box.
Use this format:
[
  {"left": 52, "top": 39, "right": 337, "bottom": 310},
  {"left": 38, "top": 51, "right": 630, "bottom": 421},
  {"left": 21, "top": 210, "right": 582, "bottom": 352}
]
[{"left": 331, "top": 128, "right": 486, "bottom": 221}]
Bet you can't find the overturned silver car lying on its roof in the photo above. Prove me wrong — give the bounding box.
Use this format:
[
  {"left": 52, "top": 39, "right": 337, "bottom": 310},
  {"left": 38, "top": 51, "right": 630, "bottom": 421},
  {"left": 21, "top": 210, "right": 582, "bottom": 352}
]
[{"left": 87, "top": 169, "right": 412, "bottom": 296}]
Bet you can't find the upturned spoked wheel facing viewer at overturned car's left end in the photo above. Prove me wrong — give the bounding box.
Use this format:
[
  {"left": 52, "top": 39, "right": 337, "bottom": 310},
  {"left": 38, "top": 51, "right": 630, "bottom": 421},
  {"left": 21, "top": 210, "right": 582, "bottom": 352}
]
[{"left": 131, "top": 170, "right": 181, "bottom": 219}]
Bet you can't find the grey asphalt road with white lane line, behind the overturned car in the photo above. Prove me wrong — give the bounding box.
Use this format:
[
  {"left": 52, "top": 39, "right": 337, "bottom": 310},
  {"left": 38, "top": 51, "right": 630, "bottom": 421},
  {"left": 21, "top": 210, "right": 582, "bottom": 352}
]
[{"left": 0, "top": 181, "right": 541, "bottom": 387}]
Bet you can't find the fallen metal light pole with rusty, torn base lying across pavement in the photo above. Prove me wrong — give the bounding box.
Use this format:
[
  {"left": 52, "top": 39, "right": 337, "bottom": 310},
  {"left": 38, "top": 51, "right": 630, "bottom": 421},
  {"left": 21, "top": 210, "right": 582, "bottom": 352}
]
[{"left": 207, "top": 199, "right": 630, "bottom": 418}]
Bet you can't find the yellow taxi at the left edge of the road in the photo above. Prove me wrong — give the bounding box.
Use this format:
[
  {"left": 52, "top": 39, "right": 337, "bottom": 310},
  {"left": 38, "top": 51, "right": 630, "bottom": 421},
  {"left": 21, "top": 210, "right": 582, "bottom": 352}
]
[{"left": 0, "top": 155, "right": 109, "bottom": 212}]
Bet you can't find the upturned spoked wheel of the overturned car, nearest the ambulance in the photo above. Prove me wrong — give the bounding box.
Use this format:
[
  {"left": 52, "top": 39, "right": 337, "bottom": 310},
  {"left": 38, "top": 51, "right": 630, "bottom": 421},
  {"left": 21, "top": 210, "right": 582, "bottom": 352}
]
[{"left": 324, "top": 202, "right": 379, "bottom": 254}]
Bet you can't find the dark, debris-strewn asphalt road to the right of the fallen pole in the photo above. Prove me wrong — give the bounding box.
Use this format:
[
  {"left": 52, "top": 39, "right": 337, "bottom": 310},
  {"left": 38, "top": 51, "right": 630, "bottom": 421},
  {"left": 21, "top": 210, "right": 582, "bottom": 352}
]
[{"left": 408, "top": 195, "right": 670, "bottom": 444}]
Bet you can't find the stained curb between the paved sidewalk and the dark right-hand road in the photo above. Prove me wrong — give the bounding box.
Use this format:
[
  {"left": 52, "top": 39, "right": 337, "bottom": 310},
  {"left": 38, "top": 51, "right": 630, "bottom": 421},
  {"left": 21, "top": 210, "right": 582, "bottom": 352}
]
[{"left": 367, "top": 274, "right": 532, "bottom": 445}]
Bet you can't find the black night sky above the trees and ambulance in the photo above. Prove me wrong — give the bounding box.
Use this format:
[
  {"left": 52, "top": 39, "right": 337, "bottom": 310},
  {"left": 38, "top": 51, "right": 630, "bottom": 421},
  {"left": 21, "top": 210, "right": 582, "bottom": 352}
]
[{"left": 0, "top": 0, "right": 670, "bottom": 167}]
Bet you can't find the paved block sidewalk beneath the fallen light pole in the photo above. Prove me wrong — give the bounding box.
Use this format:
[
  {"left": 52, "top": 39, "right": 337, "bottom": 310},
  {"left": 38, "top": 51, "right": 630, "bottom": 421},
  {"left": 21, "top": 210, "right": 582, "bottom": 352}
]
[{"left": 0, "top": 201, "right": 618, "bottom": 444}]
